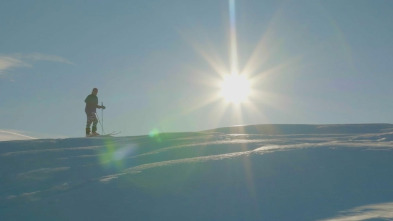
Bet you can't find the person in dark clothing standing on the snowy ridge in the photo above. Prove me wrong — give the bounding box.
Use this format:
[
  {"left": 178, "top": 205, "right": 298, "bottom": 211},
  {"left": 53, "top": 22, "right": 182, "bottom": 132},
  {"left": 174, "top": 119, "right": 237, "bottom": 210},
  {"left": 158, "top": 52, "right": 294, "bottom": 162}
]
[{"left": 85, "top": 88, "right": 105, "bottom": 136}]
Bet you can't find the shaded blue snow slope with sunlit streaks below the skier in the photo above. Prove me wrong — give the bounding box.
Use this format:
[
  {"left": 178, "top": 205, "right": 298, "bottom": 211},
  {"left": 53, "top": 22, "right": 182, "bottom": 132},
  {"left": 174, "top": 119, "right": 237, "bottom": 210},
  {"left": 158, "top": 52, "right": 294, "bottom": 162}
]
[{"left": 0, "top": 124, "right": 393, "bottom": 221}]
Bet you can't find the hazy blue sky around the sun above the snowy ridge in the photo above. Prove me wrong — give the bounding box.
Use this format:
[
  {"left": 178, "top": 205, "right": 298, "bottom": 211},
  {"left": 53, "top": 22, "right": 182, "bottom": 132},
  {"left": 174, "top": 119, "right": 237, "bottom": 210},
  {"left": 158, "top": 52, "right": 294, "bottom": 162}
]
[{"left": 0, "top": 0, "right": 393, "bottom": 137}]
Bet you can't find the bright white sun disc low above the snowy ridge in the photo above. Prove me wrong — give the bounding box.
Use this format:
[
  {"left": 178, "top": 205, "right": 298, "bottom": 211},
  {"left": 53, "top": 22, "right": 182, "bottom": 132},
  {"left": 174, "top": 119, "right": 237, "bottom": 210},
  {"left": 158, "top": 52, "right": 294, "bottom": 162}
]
[{"left": 221, "top": 74, "right": 251, "bottom": 104}]
